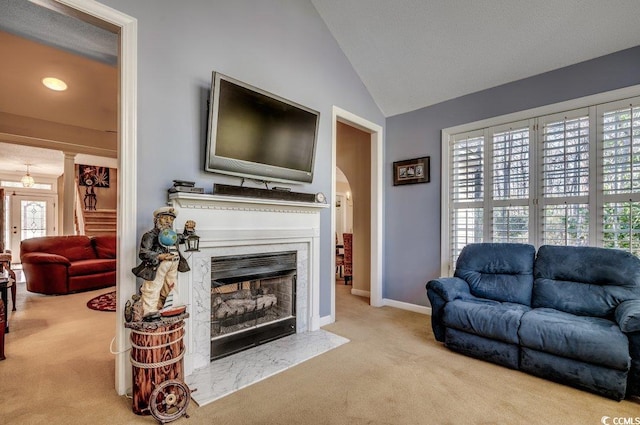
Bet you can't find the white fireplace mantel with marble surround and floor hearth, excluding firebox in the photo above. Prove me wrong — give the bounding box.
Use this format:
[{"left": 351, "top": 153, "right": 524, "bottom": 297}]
[{"left": 169, "top": 193, "right": 347, "bottom": 405}]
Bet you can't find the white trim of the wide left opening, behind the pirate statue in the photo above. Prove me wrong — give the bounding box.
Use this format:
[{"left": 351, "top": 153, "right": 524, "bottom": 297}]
[{"left": 56, "top": 0, "right": 138, "bottom": 395}]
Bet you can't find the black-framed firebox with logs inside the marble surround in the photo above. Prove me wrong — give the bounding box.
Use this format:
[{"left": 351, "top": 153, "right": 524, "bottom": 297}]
[{"left": 211, "top": 251, "right": 297, "bottom": 361}]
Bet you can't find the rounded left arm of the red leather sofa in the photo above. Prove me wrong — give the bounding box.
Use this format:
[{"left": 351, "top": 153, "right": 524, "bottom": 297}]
[{"left": 21, "top": 252, "right": 71, "bottom": 295}]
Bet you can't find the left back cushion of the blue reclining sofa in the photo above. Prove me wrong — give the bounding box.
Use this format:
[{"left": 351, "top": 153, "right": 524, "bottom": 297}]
[{"left": 455, "top": 243, "right": 536, "bottom": 306}]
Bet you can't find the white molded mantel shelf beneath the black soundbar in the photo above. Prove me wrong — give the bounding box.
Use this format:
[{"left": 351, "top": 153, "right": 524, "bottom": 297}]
[{"left": 169, "top": 192, "right": 329, "bottom": 212}]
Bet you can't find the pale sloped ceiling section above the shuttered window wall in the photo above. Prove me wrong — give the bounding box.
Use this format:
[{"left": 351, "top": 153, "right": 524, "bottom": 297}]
[{"left": 311, "top": 0, "right": 640, "bottom": 116}]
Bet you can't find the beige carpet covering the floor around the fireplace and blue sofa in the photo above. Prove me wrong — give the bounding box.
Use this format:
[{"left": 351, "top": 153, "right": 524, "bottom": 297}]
[{"left": 0, "top": 276, "right": 640, "bottom": 425}]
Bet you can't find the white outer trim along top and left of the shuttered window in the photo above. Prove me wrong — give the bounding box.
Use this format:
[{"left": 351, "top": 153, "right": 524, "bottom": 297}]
[{"left": 440, "top": 85, "right": 640, "bottom": 276}]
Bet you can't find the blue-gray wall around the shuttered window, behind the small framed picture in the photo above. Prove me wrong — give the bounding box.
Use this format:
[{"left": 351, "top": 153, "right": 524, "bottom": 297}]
[{"left": 383, "top": 46, "right": 640, "bottom": 305}]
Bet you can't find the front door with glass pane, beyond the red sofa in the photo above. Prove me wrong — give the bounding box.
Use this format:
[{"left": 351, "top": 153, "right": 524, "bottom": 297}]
[{"left": 7, "top": 195, "right": 56, "bottom": 256}]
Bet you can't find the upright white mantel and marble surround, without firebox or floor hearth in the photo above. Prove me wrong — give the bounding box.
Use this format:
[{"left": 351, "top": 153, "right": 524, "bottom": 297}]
[{"left": 169, "top": 193, "right": 329, "bottom": 375}]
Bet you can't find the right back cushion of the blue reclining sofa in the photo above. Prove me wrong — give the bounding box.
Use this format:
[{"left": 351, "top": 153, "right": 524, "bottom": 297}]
[{"left": 532, "top": 245, "right": 640, "bottom": 318}]
